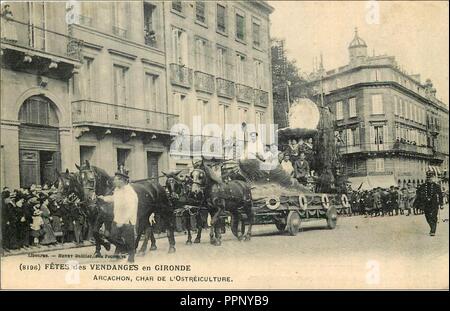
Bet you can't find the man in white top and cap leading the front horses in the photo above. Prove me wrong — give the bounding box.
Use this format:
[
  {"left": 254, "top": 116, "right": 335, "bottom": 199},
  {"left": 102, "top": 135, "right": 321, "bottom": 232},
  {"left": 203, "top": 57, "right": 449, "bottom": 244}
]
[{"left": 99, "top": 170, "right": 138, "bottom": 262}]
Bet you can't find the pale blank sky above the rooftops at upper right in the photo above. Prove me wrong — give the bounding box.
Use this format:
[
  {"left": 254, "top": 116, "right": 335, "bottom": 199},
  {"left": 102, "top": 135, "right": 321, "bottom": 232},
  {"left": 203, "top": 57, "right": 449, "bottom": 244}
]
[{"left": 268, "top": 1, "right": 449, "bottom": 105}]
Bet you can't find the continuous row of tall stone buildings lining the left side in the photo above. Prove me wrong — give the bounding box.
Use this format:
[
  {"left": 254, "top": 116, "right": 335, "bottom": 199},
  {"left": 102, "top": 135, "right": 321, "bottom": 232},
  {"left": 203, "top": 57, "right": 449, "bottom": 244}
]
[{"left": 1, "top": 1, "right": 273, "bottom": 187}]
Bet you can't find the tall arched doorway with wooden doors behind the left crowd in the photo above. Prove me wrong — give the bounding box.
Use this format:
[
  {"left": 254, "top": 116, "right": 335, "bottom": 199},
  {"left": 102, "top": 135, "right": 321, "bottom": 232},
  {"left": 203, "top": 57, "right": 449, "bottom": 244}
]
[{"left": 19, "top": 96, "right": 61, "bottom": 187}]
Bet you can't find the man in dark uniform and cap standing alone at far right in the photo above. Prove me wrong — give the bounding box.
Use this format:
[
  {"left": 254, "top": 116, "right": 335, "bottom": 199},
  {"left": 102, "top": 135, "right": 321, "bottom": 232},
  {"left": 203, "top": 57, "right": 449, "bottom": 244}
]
[{"left": 414, "top": 171, "right": 443, "bottom": 236}]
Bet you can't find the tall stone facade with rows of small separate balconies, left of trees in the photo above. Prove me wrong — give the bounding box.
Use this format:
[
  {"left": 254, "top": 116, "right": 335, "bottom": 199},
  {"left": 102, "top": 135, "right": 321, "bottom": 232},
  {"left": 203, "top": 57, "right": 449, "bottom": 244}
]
[{"left": 164, "top": 1, "right": 273, "bottom": 168}]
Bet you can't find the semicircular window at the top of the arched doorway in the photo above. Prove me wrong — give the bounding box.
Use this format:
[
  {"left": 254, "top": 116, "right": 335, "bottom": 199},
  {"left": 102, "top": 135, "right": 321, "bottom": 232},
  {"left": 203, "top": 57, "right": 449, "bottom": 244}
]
[{"left": 19, "top": 96, "right": 58, "bottom": 126}]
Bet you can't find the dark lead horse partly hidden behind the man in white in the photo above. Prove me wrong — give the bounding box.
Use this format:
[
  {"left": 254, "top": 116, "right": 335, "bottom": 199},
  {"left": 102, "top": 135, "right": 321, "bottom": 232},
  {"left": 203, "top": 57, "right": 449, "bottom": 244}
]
[{"left": 77, "top": 161, "right": 175, "bottom": 256}]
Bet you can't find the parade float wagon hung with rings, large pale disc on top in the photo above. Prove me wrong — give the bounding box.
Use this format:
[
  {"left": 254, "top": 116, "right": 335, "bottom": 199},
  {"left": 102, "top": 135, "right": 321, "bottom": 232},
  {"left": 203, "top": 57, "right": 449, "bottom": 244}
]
[{"left": 222, "top": 99, "right": 349, "bottom": 235}]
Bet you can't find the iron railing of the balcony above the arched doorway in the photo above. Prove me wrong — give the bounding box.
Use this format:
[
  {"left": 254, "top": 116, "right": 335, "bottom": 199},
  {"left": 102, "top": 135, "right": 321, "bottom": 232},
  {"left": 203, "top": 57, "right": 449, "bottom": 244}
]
[{"left": 1, "top": 17, "right": 82, "bottom": 60}]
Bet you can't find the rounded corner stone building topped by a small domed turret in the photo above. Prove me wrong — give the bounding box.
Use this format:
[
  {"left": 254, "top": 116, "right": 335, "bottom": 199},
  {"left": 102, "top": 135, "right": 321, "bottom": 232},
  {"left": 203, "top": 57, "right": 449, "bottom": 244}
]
[{"left": 309, "top": 31, "right": 449, "bottom": 187}]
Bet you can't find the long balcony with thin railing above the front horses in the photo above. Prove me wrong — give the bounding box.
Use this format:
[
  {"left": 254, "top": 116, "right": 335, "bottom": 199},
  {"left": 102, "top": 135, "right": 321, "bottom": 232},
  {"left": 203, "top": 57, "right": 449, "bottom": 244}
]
[{"left": 72, "top": 100, "right": 178, "bottom": 133}]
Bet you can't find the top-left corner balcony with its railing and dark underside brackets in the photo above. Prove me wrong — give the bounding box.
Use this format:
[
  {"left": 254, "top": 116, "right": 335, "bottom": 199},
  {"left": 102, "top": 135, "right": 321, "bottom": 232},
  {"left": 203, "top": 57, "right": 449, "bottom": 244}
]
[{"left": 1, "top": 17, "right": 82, "bottom": 79}]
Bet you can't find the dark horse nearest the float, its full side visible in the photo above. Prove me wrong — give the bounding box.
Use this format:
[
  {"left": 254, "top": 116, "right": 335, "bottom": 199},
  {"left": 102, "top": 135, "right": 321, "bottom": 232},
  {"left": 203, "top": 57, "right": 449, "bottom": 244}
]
[{"left": 191, "top": 160, "right": 254, "bottom": 245}]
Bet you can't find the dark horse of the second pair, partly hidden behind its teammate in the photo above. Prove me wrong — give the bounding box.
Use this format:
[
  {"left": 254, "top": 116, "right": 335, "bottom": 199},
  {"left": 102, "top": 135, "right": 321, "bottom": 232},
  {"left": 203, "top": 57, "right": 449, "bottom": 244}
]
[{"left": 163, "top": 170, "right": 208, "bottom": 245}]
